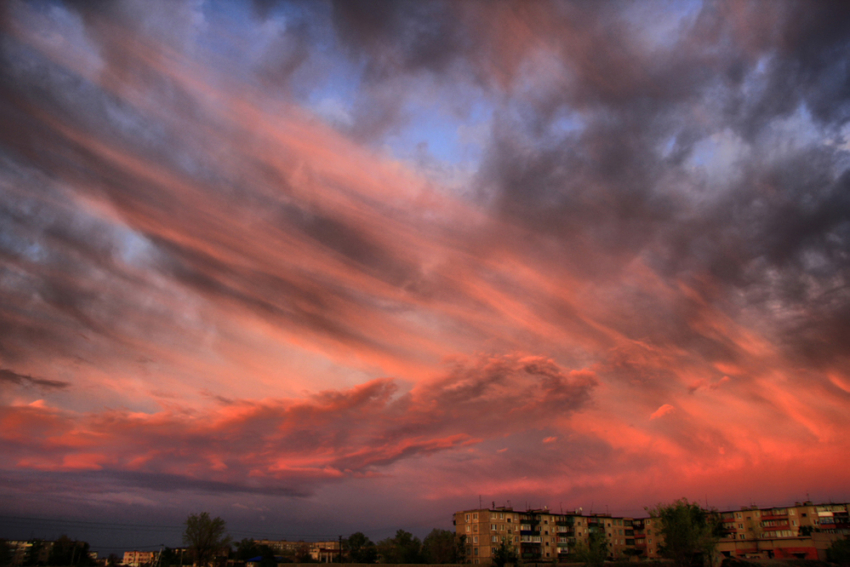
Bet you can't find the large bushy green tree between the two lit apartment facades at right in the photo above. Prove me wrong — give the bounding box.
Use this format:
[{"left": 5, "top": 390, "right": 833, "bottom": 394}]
[{"left": 648, "top": 498, "right": 722, "bottom": 567}]
